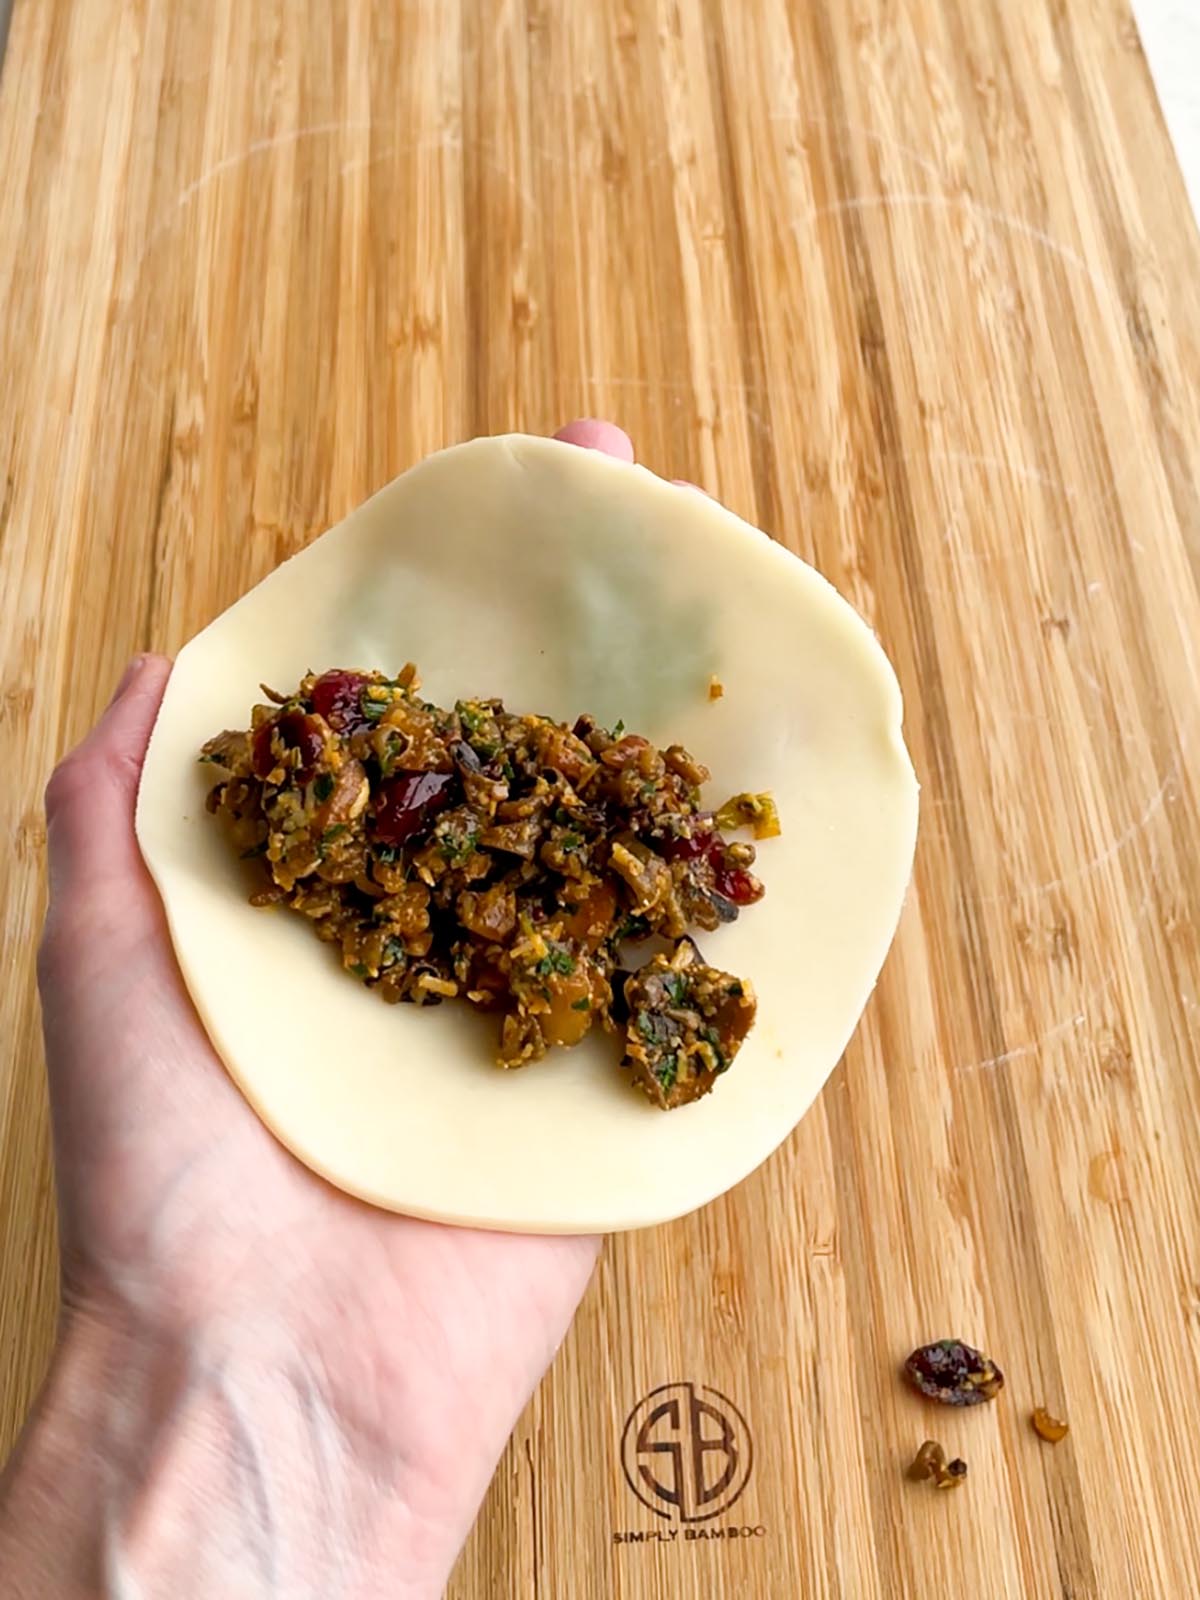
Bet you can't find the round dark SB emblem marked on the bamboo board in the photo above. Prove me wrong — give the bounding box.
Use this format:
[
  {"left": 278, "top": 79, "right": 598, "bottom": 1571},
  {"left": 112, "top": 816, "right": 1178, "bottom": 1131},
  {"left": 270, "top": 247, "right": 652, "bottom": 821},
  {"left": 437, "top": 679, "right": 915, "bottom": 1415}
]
[{"left": 621, "top": 1384, "right": 754, "bottom": 1523}]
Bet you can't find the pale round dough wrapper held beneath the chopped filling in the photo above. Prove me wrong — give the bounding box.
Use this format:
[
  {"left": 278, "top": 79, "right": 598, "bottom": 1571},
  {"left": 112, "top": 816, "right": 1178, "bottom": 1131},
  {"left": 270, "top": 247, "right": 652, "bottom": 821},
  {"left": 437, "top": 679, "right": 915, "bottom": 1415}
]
[{"left": 138, "top": 435, "right": 917, "bottom": 1232}]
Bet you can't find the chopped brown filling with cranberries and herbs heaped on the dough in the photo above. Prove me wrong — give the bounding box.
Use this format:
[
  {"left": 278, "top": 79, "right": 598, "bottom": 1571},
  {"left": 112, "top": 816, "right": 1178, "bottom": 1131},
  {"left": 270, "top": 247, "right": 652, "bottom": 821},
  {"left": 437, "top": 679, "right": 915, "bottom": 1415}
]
[{"left": 200, "top": 666, "right": 779, "bottom": 1109}]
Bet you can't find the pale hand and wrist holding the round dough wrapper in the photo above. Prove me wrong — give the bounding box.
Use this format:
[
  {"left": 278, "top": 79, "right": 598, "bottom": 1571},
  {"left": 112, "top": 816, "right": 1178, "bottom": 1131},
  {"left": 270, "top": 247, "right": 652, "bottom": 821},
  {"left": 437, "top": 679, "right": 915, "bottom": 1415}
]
[{"left": 0, "top": 421, "right": 659, "bottom": 1600}]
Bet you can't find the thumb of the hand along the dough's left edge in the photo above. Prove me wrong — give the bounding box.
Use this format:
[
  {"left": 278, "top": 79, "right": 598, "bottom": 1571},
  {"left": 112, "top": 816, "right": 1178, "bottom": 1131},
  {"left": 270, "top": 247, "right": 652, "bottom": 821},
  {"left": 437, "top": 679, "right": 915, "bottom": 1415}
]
[{"left": 46, "top": 656, "right": 171, "bottom": 915}]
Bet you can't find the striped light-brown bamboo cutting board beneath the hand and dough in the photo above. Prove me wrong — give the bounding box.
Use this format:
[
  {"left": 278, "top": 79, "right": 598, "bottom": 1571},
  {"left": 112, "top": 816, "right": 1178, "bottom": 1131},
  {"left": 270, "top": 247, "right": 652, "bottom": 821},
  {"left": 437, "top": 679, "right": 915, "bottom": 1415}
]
[{"left": 0, "top": 0, "right": 1200, "bottom": 1600}]
